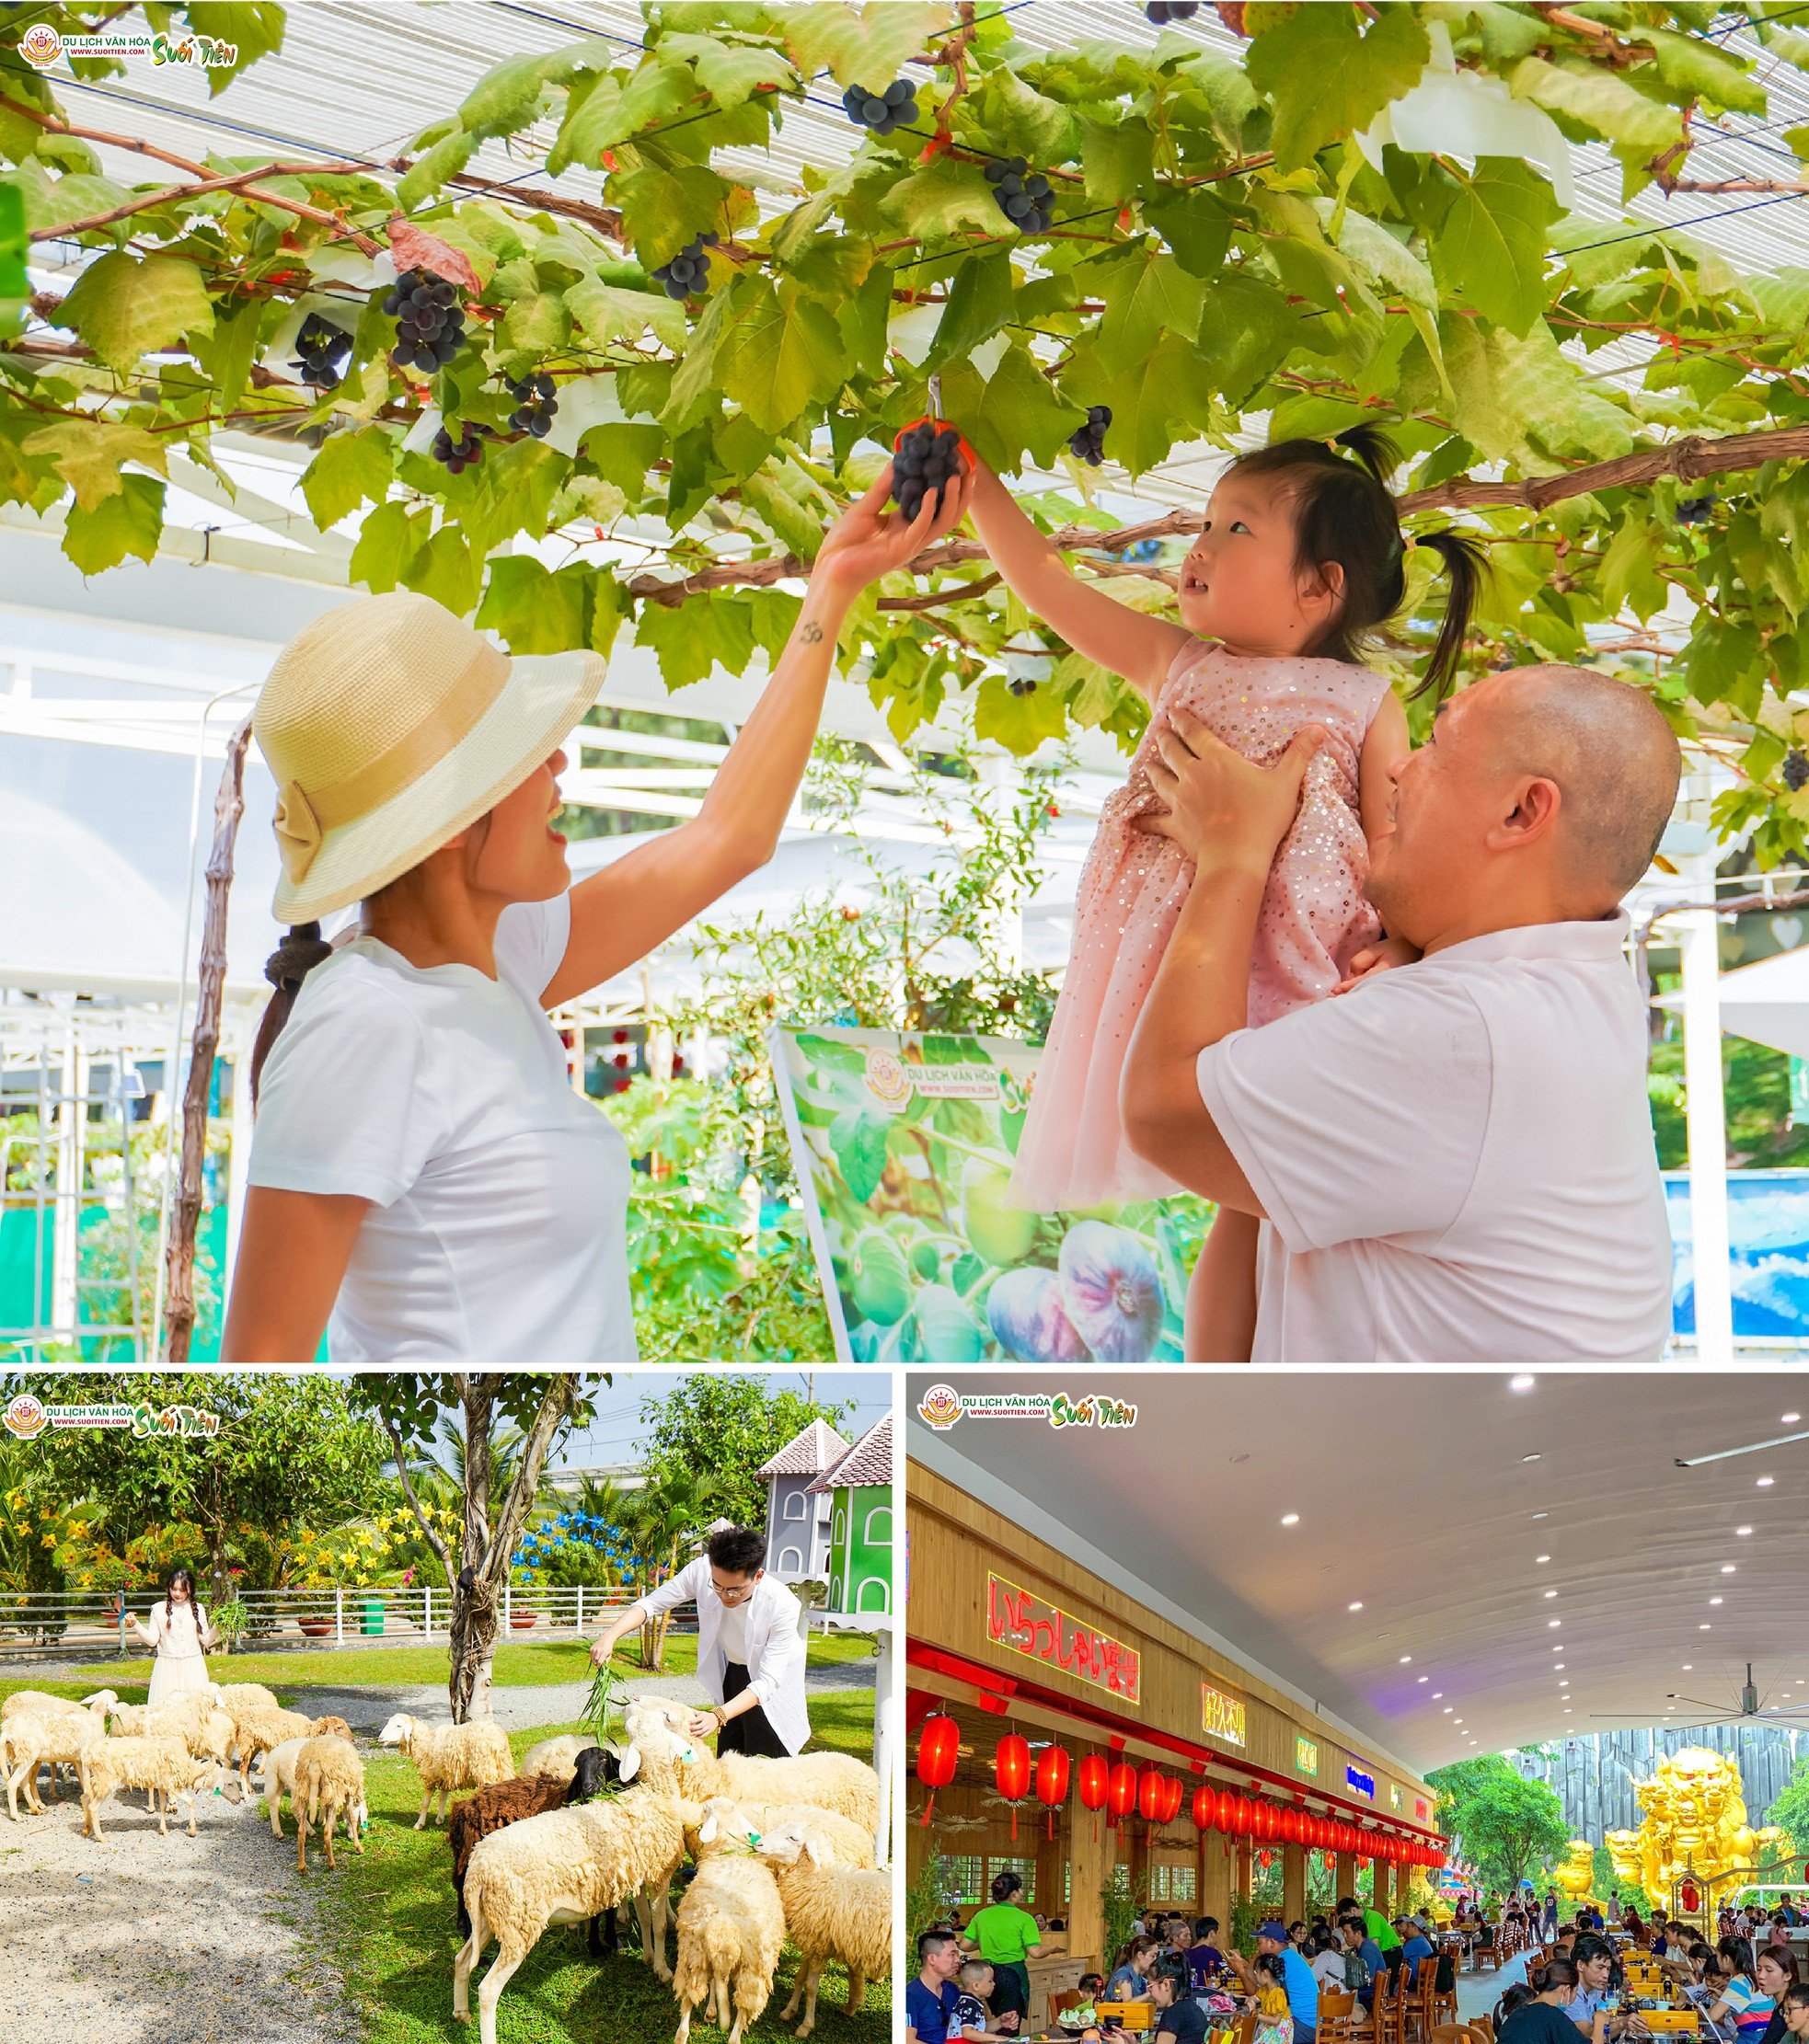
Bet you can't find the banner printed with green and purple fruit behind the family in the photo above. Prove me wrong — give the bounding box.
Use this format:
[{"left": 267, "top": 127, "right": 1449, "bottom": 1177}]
[{"left": 770, "top": 1028, "right": 1206, "bottom": 1363}]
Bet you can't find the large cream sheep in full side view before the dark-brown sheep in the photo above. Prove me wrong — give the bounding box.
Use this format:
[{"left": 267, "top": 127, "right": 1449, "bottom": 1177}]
[{"left": 452, "top": 1788, "right": 703, "bottom": 2044}]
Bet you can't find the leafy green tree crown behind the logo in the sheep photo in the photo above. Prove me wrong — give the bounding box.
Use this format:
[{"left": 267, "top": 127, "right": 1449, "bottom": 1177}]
[{"left": 19, "top": 1372, "right": 385, "bottom": 1601}]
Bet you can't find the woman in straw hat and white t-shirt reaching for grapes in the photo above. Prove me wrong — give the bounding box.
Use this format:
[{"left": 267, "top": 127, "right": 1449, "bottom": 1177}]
[{"left": 221, "top": 470, "right": 967, "bottom": 1365}]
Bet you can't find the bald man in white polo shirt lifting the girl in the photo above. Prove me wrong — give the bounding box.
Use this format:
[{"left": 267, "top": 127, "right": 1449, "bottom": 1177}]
[{"left": 1120, "top": 666, "right": 1680, "bottom": 1363}]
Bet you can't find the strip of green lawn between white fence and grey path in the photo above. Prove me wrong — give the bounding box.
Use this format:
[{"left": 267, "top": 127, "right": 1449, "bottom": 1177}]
[{"left": 0, "top": 1633, "right": 873, "bottom": 1703}]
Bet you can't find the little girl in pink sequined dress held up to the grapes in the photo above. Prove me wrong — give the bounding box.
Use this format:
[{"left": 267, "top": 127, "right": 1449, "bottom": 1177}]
[{"left": 971, "top": 427, "right": 1476, "bottom": 1361}]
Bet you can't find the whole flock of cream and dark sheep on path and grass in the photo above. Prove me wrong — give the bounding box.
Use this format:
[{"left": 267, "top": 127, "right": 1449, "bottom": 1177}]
[{"left": 0, "top": 1682, "right": 892, "bottom": 2044}]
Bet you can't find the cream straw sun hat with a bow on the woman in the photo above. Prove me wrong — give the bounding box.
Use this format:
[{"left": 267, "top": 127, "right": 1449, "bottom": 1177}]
[{"left": 251, "top": 589, "right": 603, "bottom": 924}]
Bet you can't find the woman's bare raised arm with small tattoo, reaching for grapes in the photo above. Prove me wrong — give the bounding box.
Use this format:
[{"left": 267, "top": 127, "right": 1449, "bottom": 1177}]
[{"left": 542, "top": 468, "right": 969, "bottom": 1007}]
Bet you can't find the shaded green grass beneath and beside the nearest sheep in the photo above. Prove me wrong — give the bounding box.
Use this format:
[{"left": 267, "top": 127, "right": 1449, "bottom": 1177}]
[{"left": 318, "top": 1693, "right": 892, "bottom": 2044}]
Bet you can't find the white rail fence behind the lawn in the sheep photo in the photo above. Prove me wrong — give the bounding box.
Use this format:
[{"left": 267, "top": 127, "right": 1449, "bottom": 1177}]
[{"left": 0, "top": 1584, "right": 697, "bottom": 1664}]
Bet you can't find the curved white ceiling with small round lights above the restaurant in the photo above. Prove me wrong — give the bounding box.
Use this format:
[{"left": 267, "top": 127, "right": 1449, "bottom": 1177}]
[{"left": 905, "top": 1370, "right": 1809, "bottom": 1772}]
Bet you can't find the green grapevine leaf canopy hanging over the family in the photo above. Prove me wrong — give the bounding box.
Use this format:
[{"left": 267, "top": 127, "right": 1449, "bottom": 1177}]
[{"left": 0, "top": 0, "right": 1809, "bottom": 838}]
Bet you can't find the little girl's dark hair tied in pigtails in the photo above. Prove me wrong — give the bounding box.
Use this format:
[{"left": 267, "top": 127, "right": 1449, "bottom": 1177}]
[{"left": 1227, "top": 425, "right": 1486, "bottom": 701}]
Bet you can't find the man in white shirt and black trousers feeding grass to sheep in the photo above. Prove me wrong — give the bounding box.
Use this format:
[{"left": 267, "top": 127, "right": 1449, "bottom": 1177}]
[{"left": 591, "top": 1527, "right": 810, "bottom": 1760}]
